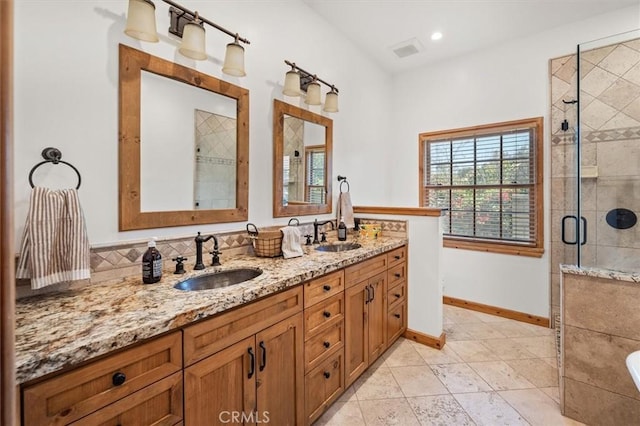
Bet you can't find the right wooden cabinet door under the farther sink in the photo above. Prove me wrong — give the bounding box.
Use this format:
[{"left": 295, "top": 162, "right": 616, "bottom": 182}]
[{"left": 367, "top": 272, "right": 387, "bottom": 364}]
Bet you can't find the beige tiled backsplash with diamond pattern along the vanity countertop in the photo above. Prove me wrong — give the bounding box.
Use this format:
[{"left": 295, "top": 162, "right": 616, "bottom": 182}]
[{"left": 16, "top": 219, "right": 407, "bottom": 299}]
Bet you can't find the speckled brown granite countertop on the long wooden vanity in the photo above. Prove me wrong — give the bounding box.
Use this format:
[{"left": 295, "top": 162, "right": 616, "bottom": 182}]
[{"left": 15, "top": 237, "right": 407, "bottom": 384}]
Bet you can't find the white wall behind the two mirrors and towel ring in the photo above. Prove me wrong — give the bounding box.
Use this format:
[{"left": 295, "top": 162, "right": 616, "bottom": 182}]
[{"left": 15, "top": 0, "right": 391, "bottom": 245}]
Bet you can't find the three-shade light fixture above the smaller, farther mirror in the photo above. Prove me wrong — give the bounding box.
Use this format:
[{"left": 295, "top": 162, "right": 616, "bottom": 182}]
[{"left": 282, "top": 59, "right": 338, "bottom": 112}]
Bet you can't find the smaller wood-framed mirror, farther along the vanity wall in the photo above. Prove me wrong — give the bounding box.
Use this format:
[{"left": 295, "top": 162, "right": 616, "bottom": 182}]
[{"left": 273, "top": 99, "right": 333, "bottom": 217}]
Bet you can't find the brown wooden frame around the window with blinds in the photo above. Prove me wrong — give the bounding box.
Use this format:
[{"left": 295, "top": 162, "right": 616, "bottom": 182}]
[{"left": 418, "top": 117, "right": 544, "bottom": 257}]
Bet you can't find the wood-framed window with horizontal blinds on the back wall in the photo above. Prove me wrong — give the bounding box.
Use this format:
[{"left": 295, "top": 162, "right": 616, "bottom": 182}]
[{"left": 419, "top": 117, "right": 543, "bottom": 257}]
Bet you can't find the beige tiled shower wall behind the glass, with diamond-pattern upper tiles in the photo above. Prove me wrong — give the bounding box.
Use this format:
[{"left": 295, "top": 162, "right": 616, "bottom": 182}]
[{"left": 550, "top": 39, "right": 640, "bottom": 320}]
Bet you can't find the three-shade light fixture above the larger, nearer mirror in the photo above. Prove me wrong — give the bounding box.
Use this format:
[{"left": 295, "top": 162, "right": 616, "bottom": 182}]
[{"left": 124, "top": 0, "right": 250, "bottom": 77}]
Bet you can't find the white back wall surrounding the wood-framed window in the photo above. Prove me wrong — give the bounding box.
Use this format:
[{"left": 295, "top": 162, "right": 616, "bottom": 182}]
[{"left": 389, "top": 7, "right": 640, "bottom": 317}]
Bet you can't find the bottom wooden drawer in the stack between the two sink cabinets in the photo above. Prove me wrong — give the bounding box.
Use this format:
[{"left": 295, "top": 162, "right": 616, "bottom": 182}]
[{"left": 305, "top": 351, "right": 344, "bottom": 424}]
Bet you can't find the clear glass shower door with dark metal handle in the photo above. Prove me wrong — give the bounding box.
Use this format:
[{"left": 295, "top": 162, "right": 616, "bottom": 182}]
[{"left": 576, "top": 30, "right": 640, "bottom": 272}]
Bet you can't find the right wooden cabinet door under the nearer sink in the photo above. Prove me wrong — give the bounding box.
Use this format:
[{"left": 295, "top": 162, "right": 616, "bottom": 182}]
[{"left": 255, "top": 313, "right": 304, "bottom": 426}]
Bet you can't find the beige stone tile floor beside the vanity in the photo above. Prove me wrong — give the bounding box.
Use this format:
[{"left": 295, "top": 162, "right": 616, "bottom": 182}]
[{"left": 315, "top": 305, "right": 582, "bottom": 426}]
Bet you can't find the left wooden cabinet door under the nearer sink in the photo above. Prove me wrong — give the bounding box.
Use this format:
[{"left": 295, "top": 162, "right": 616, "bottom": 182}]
[{"left": 184, "top": 336, "right": 258, "bottom": 426}]
